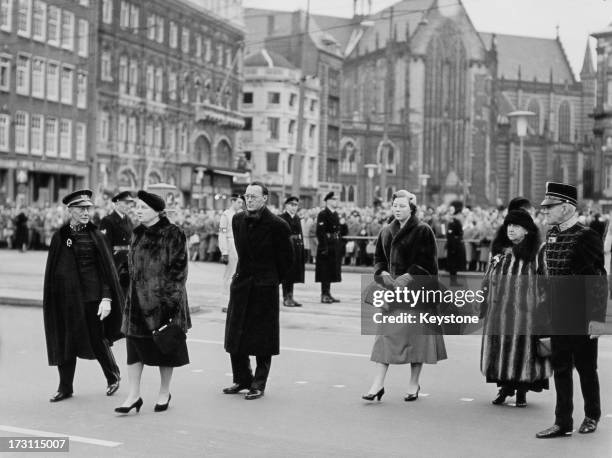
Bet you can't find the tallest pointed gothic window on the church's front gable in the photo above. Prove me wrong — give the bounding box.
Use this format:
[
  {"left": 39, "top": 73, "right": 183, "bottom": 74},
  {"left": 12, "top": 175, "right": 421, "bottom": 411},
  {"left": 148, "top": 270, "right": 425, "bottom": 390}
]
[{"left": 423, "top": 21, "right": 469, "bottom": 183}]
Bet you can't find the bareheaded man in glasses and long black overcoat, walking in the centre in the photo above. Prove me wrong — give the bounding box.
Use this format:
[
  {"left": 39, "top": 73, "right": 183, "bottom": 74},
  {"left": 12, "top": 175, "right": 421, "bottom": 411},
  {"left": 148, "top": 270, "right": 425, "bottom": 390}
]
[{"left": 223, "top": 181, "right": 293, "bottom": 399}]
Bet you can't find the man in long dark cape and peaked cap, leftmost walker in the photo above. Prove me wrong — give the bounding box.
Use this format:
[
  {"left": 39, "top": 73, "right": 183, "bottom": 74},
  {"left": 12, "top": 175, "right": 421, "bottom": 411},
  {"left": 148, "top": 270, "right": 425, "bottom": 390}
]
[{"left": 43, "top": 189, "right": 123, "bottom": 402}]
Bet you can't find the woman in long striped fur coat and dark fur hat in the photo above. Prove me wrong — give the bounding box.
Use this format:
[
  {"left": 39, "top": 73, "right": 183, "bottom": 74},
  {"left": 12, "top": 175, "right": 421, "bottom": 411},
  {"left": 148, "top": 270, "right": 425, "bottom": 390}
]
[{"left": 480, "top": 210, "right": 551, "bottom": 407}]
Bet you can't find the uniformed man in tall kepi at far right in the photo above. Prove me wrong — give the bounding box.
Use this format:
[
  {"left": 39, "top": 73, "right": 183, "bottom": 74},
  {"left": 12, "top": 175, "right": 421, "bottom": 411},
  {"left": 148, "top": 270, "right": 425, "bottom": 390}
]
[{"left": 536, "top": 182, "right": 607, "bottom": 439}]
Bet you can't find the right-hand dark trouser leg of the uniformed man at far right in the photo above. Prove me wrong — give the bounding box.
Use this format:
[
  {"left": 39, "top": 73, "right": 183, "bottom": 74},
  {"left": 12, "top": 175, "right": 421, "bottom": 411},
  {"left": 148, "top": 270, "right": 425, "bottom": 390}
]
[{"left": 574, "top": 336, "right": 601, "bottom": 420}]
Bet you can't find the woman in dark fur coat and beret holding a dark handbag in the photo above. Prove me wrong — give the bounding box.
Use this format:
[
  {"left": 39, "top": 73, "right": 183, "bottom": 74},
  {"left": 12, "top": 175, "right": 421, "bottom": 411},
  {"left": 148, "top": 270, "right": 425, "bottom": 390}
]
[{"left": 115, "top": 191, "right": 191, "bottom": 413}]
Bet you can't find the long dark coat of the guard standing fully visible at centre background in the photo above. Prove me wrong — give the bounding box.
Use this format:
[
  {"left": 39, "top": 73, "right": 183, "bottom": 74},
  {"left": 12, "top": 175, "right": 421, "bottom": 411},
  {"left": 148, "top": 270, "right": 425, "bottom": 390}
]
[{"left": 315, "top": 208, "right": 344, "bottom": 283}]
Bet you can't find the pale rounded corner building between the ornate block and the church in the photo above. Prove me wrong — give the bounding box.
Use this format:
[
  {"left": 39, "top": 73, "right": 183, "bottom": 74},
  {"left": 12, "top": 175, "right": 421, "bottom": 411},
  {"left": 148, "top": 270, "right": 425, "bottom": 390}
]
[{"left": 241, "top": 49, "right": 321, "bottom": 208}]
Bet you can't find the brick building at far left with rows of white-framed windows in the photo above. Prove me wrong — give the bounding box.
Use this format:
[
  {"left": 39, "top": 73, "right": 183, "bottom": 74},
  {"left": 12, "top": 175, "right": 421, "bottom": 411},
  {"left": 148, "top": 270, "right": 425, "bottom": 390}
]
[{"left": 0, "top": 0, "right": 97, "bottom": 205}]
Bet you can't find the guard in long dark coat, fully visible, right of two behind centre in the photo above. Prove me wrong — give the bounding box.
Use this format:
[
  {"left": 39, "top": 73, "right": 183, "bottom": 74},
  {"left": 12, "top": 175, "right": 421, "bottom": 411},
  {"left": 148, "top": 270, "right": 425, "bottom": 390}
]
[{"left": 315, "top": 192, "right": 343, "bottom": 304}]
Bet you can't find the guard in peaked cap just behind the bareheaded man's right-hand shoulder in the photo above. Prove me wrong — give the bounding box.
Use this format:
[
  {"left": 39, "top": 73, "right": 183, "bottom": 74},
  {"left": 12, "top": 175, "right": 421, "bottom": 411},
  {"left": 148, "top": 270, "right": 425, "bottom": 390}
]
[{"left": 280, "top": 196, "right": 305, "bottom": 307}]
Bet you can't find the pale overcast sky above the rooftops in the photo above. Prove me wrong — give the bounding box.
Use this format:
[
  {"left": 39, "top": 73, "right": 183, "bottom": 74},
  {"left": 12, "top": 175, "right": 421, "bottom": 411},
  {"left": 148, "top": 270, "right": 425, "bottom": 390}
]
[{"left": 243, "top": 0, "right": 612, "bottom": 79}]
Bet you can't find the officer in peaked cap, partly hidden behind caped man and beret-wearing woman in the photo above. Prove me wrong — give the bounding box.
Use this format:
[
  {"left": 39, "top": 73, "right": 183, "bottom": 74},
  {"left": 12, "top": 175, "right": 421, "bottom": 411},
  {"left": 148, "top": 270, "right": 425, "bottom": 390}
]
[{"left": 100, "top": 191, "right": 134, "bottom": 296}]
